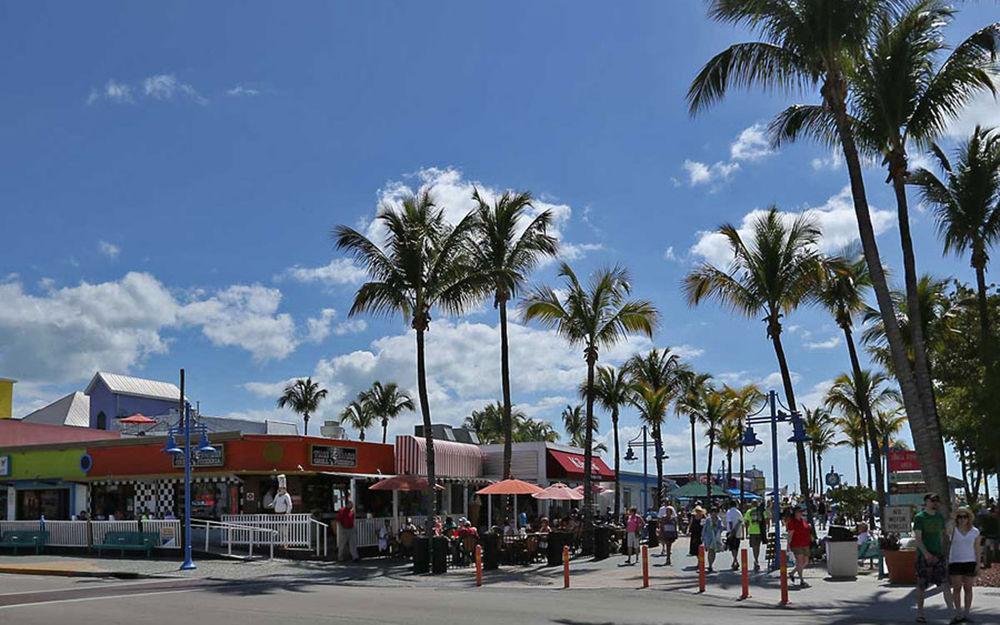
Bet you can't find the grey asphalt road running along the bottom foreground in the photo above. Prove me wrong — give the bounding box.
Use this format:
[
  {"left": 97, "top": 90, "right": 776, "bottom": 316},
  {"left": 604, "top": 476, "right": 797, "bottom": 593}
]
[{"left": 0, "top": 576, "right": 956, "bottom": 625}]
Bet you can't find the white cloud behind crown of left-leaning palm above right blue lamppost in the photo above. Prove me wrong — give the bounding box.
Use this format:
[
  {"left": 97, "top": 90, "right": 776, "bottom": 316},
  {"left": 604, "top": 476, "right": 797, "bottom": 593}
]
[{"left": 691, "top": 187, "right": 894, "bottom": 268}]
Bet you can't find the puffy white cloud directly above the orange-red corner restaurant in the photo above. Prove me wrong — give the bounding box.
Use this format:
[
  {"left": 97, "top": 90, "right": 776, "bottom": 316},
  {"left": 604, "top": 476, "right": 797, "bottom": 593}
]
[{"left": 180, "top": 285, "right": 298, "bottom": 362}]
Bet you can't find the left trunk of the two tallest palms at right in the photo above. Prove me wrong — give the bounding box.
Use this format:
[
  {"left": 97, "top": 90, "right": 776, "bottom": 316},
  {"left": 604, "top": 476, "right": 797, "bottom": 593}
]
[{"left": 822, "top": 77, "right": 949, "bottom": 513}]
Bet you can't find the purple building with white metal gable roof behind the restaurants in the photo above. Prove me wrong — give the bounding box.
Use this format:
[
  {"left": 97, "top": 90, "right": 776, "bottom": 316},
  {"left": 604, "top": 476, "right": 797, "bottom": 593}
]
[{"left": 84, "top": 371, "right": 181, "bottom": 430}]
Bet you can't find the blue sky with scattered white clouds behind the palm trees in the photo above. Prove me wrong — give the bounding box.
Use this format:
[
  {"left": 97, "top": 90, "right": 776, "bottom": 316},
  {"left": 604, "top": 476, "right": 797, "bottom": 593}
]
[{"left": 0, "top": 2, "right": 1000, "bottom": 488}]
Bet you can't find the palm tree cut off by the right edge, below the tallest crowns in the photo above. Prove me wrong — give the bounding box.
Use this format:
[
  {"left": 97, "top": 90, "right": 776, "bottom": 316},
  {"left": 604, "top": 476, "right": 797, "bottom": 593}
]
[{"left": 909, "top": 126, "right": 1000, "bottom": 389}]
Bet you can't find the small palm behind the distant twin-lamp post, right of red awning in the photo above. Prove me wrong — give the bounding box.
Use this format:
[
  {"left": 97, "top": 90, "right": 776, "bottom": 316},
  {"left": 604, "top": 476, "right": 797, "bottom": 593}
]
[{"left": 624, "top": 348, "right": 683, "bottom": 507}]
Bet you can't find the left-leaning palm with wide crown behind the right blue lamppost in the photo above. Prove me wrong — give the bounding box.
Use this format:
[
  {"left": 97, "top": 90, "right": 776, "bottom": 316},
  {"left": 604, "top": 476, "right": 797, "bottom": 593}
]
[{"left": 684, "top": 206, "right": 822, "bottom": 516}]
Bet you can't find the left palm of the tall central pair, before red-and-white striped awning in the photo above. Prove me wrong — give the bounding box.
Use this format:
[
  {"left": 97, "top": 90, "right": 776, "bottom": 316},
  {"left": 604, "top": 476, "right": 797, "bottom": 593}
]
[{"left": 333, "top": 192, "right": 485, "bottom": 532}]
